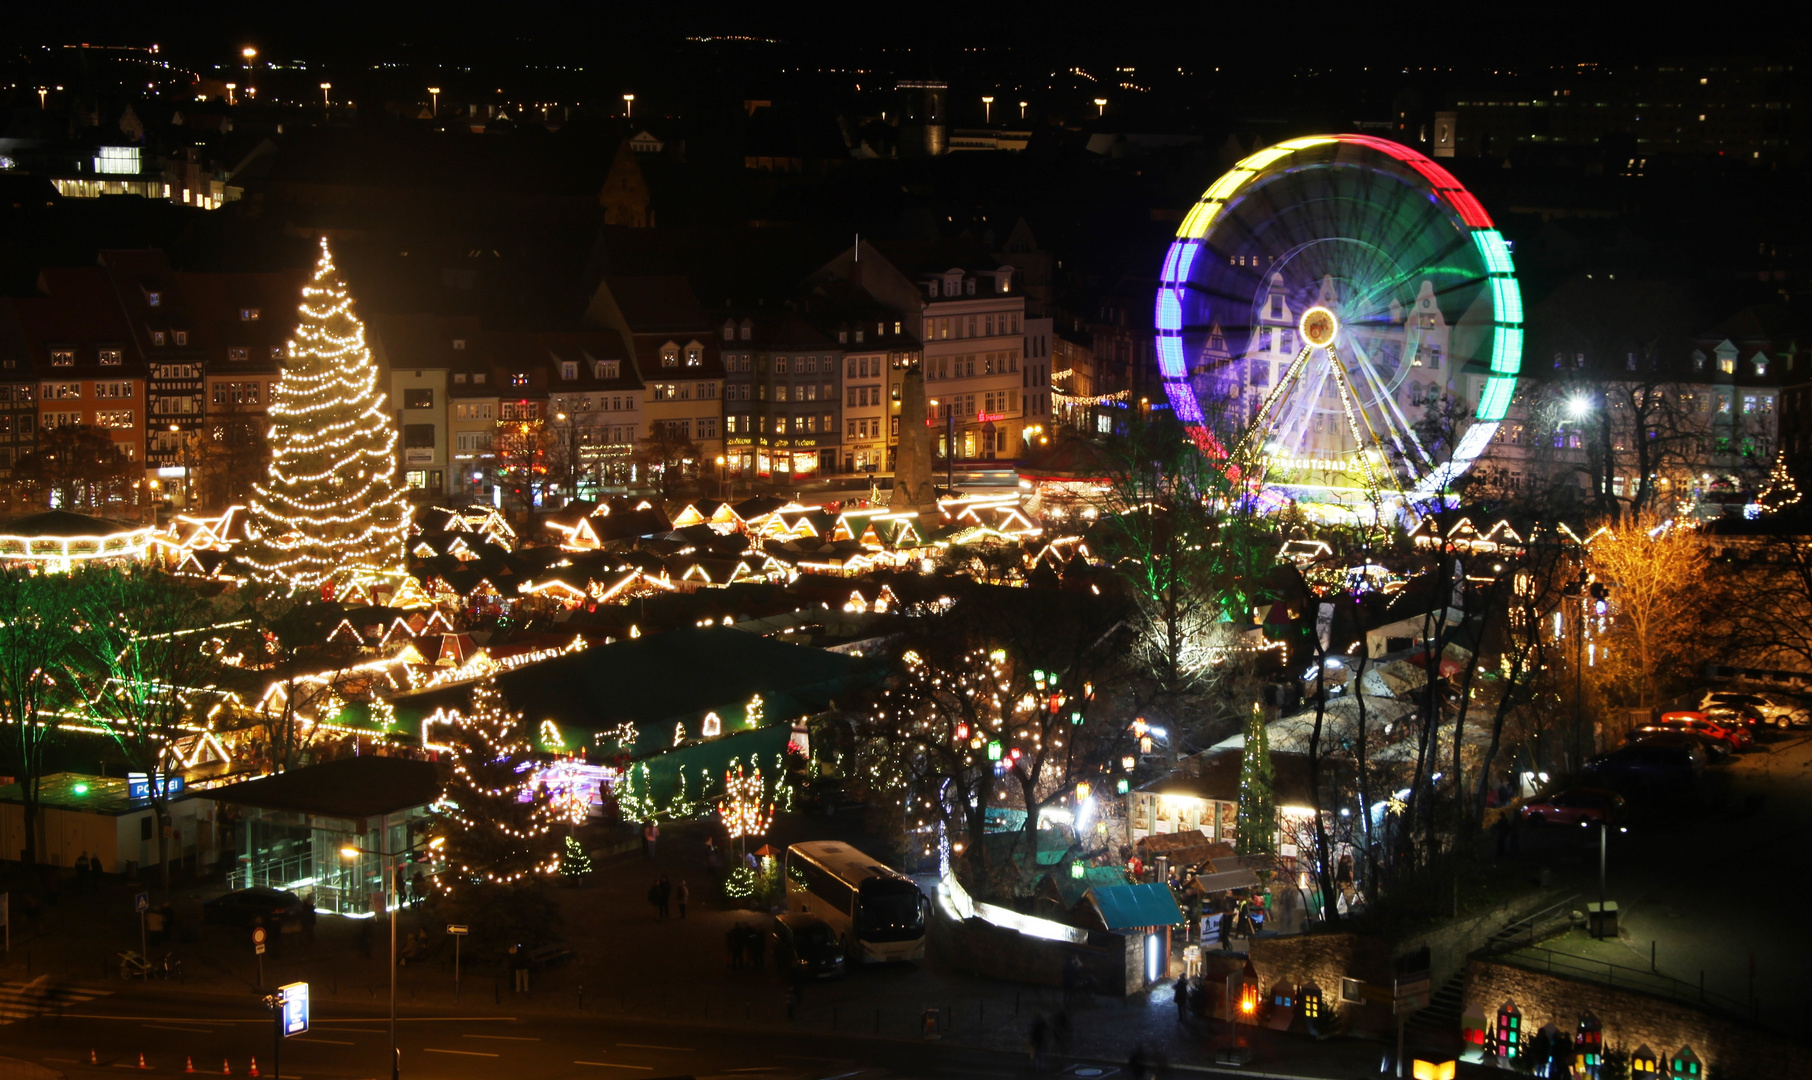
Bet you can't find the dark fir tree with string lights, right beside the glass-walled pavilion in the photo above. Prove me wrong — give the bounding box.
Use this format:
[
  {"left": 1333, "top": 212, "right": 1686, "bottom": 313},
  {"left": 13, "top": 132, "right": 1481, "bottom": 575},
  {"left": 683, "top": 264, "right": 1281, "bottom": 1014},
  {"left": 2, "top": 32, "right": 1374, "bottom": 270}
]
[{"left": 435, "top": 680, "right": 560, "bottom": 899}]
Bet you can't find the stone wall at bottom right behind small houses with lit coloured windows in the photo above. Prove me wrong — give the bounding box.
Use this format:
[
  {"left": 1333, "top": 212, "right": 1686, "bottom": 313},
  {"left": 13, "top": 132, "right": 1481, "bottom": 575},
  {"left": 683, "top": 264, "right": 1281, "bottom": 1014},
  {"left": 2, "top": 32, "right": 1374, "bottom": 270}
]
[{"left": 1464, "top": 960, "right": 1812, "bottom": 1080}]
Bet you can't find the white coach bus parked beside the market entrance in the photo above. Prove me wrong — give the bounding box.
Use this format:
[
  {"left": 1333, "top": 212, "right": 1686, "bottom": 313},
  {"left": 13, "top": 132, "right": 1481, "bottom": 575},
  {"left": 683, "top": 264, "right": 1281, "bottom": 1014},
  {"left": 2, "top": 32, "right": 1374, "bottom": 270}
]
[{"left": 786, "top": 841, "right": 931, "bottom": 964}]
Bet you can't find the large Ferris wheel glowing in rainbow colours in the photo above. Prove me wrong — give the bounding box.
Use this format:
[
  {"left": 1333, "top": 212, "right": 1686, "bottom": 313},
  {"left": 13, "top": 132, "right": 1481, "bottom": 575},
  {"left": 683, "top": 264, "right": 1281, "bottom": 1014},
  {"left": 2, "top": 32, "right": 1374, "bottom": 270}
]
[{"left": 1156, "top": 134, "right": 1522, "bottom": 513}]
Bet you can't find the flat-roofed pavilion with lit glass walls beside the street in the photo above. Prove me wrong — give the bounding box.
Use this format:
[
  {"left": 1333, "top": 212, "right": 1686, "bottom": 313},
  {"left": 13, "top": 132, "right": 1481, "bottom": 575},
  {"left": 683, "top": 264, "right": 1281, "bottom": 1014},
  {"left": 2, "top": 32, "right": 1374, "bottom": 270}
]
[{"left": 198, "top": 754, "right": 440, "bottom": 915}]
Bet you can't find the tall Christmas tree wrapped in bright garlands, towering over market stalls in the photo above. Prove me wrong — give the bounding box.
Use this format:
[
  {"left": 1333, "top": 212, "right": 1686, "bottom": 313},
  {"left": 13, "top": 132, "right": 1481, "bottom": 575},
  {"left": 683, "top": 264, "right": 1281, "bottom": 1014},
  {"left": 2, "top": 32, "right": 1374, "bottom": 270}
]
[{"left": 245, "top": 239, "right": 406, "bottom": 589}]
